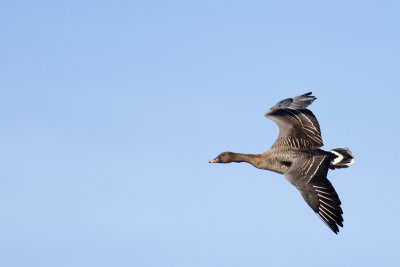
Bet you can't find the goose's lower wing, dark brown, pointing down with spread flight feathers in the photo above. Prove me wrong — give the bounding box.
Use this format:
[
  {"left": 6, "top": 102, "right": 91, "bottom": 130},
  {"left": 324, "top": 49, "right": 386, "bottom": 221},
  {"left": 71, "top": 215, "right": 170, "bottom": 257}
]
[{"left": 284, "top": 155, "right": 343, "bottom": 234}]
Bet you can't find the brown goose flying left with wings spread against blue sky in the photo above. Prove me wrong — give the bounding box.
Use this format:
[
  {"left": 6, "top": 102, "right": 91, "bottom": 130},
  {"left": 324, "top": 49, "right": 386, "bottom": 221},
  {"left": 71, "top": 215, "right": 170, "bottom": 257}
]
[{"left": 210, "top": 92, "right": 354, "bottom": 234}]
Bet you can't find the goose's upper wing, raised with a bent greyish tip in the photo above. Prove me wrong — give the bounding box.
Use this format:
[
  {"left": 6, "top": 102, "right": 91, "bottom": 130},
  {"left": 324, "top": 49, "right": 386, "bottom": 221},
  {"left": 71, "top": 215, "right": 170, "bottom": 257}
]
[{"left": 265, "top": 92, "right": 323, "bottom": 148}]
